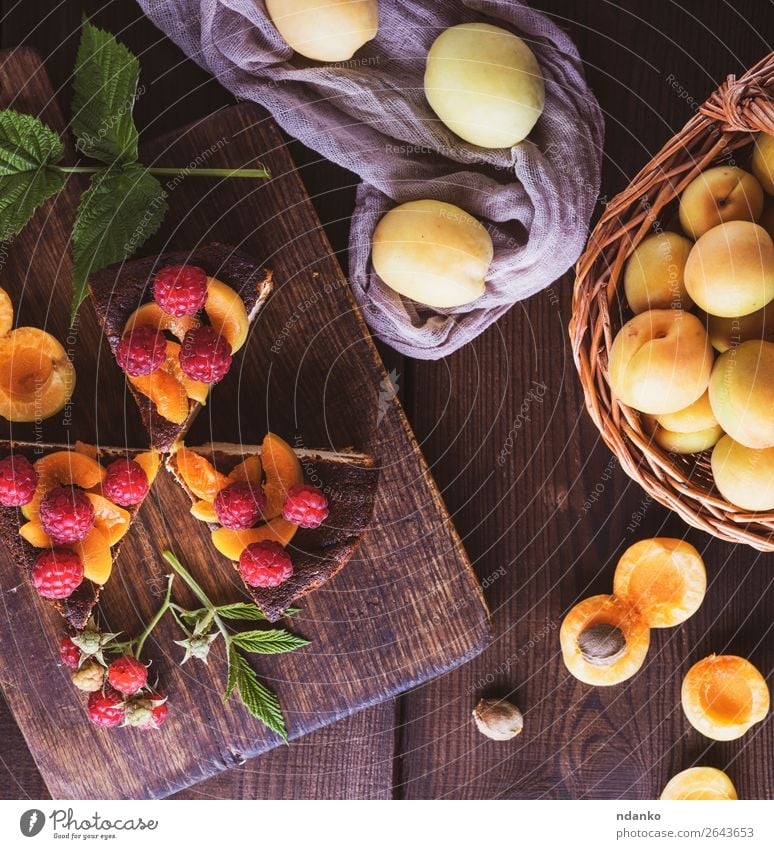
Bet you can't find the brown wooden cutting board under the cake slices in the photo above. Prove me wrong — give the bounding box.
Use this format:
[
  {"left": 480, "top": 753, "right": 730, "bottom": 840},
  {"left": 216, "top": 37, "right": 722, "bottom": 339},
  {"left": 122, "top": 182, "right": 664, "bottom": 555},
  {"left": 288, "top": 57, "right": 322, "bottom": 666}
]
[{"left": 0, "top": 49, "right": 491, "bottom": 798}]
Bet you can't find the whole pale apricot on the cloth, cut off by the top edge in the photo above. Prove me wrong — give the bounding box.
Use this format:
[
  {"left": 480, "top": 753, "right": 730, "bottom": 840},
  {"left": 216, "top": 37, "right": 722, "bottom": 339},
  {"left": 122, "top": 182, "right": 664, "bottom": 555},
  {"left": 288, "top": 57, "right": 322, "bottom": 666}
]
[{"left": 266, "top": 0, "right": 379, "bottom": 62}]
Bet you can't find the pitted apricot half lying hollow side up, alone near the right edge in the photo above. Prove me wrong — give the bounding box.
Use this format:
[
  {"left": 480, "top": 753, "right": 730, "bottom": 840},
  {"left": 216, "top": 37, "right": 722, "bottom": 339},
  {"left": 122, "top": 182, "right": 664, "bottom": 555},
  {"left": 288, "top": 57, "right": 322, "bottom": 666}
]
[{"left": 682, "top": 654, "right": 770, "bottom": 740}]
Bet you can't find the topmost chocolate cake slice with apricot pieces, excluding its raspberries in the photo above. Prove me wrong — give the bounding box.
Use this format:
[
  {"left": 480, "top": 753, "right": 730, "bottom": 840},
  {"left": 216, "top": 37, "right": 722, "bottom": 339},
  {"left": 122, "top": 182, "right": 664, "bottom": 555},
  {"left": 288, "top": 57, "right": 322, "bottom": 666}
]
[{"left": 89, "top": 243, "right": 272, "bottom": 451}]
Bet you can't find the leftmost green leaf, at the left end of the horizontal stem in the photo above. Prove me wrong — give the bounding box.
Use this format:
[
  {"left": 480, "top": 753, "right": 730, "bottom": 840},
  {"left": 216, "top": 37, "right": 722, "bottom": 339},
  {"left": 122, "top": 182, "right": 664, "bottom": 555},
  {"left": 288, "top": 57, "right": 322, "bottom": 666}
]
[{"left": 0, "top": 109, "right": 67, "bottom": 240}]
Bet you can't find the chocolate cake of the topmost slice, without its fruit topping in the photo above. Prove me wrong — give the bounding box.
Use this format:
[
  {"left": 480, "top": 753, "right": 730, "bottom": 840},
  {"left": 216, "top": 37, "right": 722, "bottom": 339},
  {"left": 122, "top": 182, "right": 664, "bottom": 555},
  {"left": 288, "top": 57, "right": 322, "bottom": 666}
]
[{"left": 89, "top": 243, "right": 272, "bottom": 451}]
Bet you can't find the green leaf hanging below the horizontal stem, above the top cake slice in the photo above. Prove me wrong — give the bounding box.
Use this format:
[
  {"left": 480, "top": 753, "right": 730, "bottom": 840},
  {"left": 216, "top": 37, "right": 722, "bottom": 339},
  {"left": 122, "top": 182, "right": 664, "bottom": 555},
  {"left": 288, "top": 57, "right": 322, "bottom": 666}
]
[{"left": 71, "top": 164, "right": 167, "bottom": 320}]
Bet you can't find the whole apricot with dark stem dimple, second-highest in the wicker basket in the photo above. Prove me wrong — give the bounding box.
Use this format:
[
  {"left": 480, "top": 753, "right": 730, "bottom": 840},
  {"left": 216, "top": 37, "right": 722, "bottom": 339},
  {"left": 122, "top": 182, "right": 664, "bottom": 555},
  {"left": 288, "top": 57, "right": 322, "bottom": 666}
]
[{"left": 680, "top": 165, "right": 763, "bottom": 239}]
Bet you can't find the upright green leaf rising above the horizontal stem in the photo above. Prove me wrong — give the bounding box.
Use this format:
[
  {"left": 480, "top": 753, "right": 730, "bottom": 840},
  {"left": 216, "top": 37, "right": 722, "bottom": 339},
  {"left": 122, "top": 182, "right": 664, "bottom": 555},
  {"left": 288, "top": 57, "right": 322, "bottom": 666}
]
[{"left": 72, "top": 21, "right": 140, "bottom": 164}]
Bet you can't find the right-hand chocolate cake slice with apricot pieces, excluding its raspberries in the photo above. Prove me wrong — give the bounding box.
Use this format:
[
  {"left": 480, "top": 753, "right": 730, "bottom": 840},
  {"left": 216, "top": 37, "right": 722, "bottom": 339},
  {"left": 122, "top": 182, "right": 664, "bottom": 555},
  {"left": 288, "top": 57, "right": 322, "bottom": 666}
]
[{"left": 167, "top": 433, "right": 379, "bottom": 622}]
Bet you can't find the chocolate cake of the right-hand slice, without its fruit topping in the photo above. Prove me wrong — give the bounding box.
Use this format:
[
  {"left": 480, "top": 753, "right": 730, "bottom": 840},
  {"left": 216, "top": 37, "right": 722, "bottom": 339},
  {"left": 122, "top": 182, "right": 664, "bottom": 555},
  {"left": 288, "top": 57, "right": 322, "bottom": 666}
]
[{"left": 167, "top": 442, "right": 379, "bottom": 622}]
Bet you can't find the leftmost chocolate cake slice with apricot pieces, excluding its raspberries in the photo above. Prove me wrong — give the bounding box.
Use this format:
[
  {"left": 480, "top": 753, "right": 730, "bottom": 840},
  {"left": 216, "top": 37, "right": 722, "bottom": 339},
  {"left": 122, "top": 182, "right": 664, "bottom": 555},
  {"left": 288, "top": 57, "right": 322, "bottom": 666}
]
[{"left": 0, "top": 440, "right": 161, "bottom": 630}]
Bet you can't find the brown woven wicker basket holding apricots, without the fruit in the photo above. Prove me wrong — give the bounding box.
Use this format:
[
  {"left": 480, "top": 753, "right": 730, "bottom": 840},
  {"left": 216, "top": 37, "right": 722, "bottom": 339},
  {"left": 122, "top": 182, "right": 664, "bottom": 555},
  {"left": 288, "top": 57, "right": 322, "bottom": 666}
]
[{"left": 569, "top": 52, "right": 774, "bottom": 551}]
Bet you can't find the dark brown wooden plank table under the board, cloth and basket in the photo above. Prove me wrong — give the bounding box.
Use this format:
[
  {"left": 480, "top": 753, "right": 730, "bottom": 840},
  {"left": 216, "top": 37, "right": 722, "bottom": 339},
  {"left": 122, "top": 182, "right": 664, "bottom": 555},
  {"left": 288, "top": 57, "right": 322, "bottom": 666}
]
[{"left": 0, "top": 0, "right": 774, "bottom": 799}]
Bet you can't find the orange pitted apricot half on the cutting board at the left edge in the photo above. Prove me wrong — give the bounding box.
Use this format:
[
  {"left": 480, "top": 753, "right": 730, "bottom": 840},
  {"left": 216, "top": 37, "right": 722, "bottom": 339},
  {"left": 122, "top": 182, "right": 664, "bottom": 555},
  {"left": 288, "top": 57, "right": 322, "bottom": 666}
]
[{"left": 0, "top": 327, "right": 75, "bottom": 422}]
